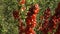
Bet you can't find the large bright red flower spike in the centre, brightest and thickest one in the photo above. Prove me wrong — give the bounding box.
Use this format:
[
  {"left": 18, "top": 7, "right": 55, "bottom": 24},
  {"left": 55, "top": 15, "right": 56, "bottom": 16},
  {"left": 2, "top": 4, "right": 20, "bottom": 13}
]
[{"left": 25, "top": 4, "right": 39, "bottom": 34}]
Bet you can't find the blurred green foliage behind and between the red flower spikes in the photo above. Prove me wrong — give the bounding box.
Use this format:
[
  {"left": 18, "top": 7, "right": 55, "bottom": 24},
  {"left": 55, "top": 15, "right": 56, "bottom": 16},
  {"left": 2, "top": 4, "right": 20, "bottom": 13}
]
[{"left": 0, "top": 0, "right": 60, "bottom": 34}]
